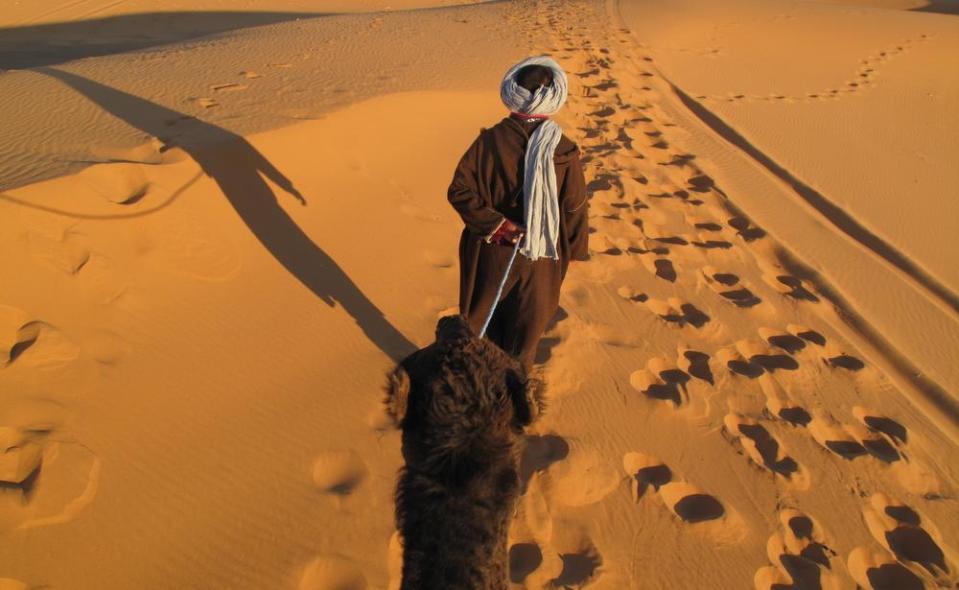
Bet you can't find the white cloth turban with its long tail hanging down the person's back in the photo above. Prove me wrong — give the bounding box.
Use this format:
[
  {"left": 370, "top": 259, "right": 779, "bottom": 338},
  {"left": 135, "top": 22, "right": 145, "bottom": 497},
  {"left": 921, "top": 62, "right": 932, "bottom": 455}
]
[{"left": 500, "top": 56, "right": 567, "bottom": 260}]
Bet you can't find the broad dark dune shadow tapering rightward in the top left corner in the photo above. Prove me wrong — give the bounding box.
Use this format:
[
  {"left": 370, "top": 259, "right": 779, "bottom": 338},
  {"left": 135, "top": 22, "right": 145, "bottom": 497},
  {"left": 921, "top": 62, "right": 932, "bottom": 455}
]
[{"left": 0, "top": 11, "right": 328, "bottom": 70}]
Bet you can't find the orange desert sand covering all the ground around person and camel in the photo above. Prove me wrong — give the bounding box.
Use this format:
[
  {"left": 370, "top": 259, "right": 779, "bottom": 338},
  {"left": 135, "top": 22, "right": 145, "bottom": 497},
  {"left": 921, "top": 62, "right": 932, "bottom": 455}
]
[{"left": 0, "top": 0, "right": 959, "bottom": 590}]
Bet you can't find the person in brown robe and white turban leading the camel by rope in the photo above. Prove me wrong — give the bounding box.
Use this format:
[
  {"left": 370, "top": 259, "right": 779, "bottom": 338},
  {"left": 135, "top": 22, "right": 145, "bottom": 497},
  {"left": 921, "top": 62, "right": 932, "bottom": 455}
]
[{"left": 447, "top": 57, "right": 589, "bottom": 368}]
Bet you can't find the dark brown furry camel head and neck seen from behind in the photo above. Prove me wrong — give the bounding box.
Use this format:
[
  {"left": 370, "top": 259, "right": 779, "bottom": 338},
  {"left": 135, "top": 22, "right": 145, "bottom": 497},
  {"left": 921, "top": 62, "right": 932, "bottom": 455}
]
[{"left": 387, "top": 316, "right": 541, "bottom": 590}]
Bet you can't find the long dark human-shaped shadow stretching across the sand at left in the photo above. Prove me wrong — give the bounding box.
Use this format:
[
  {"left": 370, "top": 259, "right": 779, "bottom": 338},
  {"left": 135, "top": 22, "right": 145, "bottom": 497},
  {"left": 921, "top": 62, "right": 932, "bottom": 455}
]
[{"left": 41, "top": 67, "right": 417, "bottom": 361}]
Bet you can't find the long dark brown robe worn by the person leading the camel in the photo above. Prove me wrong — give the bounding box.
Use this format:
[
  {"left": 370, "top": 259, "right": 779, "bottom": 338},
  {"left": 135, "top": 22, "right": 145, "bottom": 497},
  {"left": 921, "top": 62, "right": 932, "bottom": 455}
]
[{"left": 447, "top": 117, "right": 589, "bottom": 367}]
